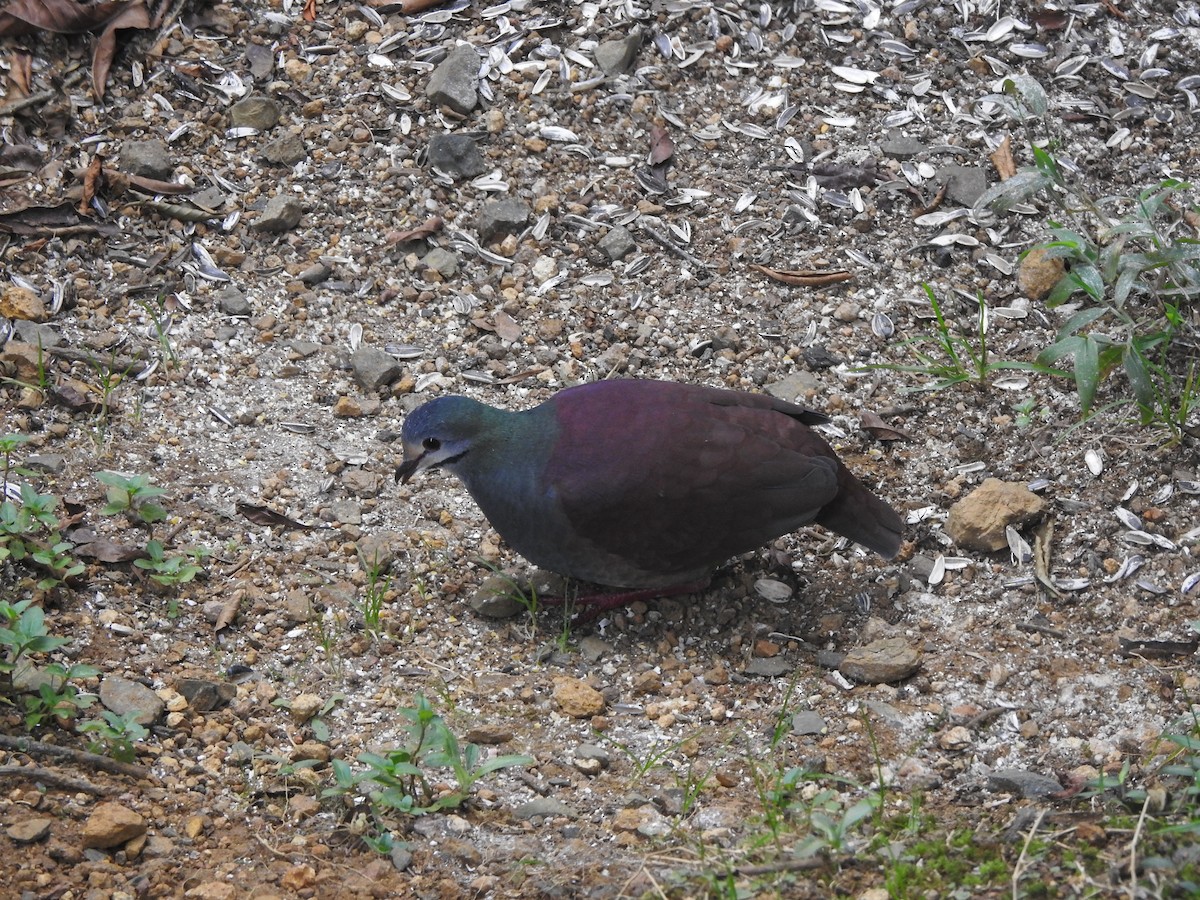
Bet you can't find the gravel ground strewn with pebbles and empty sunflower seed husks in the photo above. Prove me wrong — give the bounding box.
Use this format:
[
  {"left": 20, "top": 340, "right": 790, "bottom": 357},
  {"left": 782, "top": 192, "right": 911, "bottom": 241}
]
[{"left": 0, "top": 0, "right": 1200, "bottom": 898}]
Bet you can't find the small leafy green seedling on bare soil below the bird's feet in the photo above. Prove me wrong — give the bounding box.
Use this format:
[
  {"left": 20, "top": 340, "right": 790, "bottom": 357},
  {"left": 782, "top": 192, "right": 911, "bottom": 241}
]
[{"left": 325, "top": 694, "right": 534, "bottom": 835}]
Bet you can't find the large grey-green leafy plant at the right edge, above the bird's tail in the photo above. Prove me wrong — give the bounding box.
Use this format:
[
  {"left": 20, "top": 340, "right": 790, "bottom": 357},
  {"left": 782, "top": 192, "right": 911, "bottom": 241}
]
[{"left": 976, "top": 76, "right": 1200, "bottom": 439}]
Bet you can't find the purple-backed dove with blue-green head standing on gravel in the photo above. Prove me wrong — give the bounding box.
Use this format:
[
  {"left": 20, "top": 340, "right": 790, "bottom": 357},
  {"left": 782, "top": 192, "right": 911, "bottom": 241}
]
[{"left": 396, "top": 378, "right": 904, "bottom": 608}]
